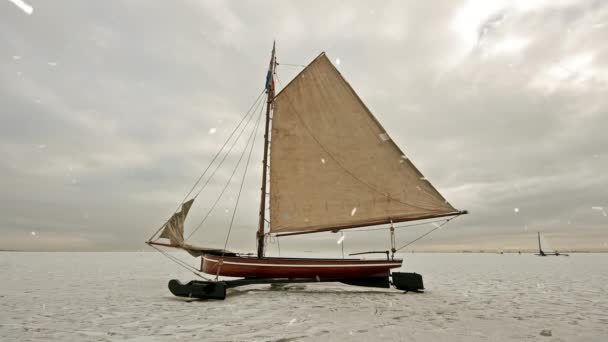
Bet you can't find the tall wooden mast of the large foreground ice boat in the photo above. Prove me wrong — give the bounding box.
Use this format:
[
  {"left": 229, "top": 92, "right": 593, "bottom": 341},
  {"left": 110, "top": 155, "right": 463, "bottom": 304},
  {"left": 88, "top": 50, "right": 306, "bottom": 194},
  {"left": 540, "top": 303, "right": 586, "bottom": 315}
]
[{"left": 256, "top": 42, "right": 276, "bottom": 258}]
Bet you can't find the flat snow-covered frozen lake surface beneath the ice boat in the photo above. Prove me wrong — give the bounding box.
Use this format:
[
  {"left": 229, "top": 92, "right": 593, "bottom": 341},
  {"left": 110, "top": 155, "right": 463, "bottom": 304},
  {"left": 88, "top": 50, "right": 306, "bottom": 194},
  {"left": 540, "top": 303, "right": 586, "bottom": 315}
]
[{"left": 0, "top": 252, "right": 608, "bottom": 341}]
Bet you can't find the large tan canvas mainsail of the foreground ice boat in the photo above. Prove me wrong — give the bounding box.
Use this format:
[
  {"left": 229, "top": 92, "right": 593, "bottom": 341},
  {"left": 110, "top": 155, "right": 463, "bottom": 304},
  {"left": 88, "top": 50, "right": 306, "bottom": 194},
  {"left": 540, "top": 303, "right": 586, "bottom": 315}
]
[{"left": 270, "top": 53, "right": 458, "bottom": 233}]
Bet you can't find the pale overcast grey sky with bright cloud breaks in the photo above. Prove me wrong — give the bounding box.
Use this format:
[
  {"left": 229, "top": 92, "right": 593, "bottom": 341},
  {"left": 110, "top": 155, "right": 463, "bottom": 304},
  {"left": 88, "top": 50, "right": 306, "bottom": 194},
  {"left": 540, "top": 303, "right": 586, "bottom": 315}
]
[{"left": 0, "top": 0, "right": 608, "bottom": 253}]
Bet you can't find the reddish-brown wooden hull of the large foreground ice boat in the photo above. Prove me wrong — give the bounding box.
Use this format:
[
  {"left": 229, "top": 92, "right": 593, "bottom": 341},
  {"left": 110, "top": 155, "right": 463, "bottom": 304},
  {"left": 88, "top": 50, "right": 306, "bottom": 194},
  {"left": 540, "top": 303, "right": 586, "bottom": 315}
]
[{"left": 201, "top": 254, "right": 402, "bottom": 279}]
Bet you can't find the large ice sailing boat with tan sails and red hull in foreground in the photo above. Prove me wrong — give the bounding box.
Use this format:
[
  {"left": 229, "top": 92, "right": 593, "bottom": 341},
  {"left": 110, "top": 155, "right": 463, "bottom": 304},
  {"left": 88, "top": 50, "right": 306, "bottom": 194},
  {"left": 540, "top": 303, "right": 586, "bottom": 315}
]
[{"left": 147, "top": 45, "right": 466, "bottom": 298}]
